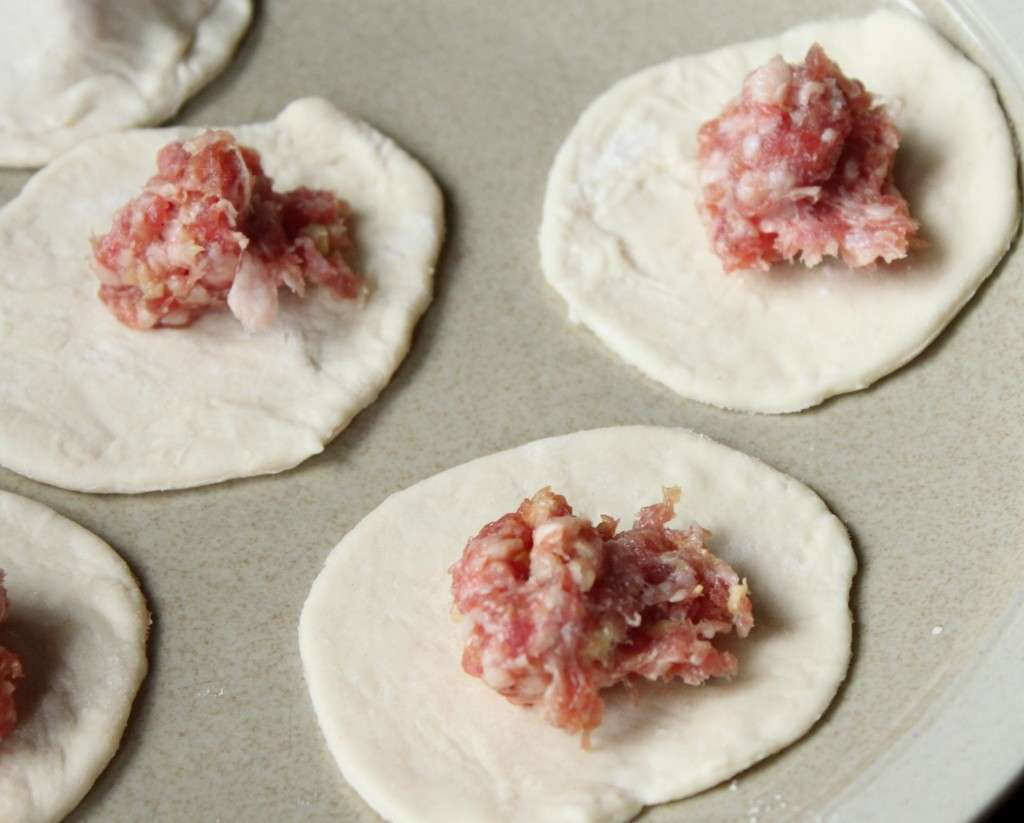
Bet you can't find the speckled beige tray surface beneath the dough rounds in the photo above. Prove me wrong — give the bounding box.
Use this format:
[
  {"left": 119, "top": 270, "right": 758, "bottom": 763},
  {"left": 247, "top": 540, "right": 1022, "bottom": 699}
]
[{"left": 0, "top": 0, "right": 1024, "bottom": 823}]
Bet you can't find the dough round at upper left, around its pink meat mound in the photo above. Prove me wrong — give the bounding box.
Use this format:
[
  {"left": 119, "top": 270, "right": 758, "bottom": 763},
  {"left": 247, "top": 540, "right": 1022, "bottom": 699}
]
[{"left": 0, "top": 98, "right": 443, "bottom": 492}]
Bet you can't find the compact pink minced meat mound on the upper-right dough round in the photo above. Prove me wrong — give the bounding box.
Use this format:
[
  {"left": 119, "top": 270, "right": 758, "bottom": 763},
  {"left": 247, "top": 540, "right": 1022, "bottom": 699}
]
[{"left": 697, "top": 45, "right": 918, "bottom": 271}]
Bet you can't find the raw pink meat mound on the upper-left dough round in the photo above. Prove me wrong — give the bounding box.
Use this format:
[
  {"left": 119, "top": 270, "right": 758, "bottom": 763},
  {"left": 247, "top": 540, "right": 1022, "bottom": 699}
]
[{"left": 92, "top": 131, "right": 365, "bottom": 330}]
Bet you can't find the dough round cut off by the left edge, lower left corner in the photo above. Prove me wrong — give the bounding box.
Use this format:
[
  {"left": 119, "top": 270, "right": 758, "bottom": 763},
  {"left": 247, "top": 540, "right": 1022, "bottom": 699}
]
[{"left": 0, "top": 491, "right": 150, "bottom": 823}]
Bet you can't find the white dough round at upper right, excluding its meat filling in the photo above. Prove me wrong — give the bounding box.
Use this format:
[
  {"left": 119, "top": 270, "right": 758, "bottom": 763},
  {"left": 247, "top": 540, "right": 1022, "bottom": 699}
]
[{"left": 541, "top": 11, "right": 1018, "bottom": 413}]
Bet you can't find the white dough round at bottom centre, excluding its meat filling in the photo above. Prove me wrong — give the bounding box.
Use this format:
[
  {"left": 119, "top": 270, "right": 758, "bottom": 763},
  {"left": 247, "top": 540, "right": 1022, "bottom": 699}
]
[{"left": 299, "top": 427, "right": 856, "bottom": 823}]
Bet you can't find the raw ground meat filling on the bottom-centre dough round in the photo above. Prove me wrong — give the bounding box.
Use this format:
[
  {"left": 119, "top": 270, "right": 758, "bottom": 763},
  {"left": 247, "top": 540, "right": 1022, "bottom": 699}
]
[{"left": 451, "top": 488, "right": 754, "bottom": 745}]
